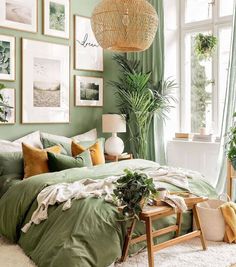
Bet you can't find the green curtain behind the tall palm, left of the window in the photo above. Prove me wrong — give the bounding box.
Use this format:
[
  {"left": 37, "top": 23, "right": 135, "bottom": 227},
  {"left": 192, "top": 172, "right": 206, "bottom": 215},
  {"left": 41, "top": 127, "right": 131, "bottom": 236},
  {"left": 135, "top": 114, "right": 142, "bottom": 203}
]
[{"left": 127, "top": 0, "right": 166, "bottom": 165}]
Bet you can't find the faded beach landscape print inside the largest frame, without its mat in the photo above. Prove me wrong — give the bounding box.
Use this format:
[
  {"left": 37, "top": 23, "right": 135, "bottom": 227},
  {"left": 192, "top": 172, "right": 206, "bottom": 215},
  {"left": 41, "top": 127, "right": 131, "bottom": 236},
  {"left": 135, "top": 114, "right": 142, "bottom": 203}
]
[{"left": 33, "top": 57, "right": 61, "bottom": 107}]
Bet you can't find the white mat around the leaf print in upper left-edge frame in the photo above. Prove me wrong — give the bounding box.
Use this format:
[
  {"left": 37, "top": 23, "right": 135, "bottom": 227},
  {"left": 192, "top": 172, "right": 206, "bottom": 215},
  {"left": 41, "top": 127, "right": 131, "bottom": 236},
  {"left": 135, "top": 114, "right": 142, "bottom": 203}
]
[{"left": 0, "top": 35, "right": 16, "bottom": 81}]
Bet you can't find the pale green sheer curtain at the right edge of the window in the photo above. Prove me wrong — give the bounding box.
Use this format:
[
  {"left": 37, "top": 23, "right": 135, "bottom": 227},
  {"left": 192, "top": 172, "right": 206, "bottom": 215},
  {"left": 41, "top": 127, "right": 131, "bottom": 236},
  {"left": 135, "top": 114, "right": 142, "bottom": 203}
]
[{"left": 216, "top": 3, "right": 236, "bottom": 199}]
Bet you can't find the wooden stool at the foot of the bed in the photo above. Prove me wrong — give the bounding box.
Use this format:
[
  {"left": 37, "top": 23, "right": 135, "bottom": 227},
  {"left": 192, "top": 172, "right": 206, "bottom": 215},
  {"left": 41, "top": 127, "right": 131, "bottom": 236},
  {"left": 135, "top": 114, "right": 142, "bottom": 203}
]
[{"left": 121, "top": 197, "right": 208, "bottom": 267}]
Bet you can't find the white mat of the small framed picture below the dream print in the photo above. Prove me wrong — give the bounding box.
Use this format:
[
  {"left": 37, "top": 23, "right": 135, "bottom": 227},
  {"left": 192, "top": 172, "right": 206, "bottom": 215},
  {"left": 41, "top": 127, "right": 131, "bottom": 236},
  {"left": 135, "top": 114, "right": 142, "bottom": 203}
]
[{"left": 75, "top": 76, "right": 103, "bottom": 107}]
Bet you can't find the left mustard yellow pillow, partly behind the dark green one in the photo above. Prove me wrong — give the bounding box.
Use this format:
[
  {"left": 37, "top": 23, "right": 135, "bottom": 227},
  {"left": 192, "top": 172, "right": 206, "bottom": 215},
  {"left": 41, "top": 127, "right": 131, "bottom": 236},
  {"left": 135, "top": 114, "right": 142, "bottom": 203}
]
[{"left": 22, "top": 143, "right": 61, "bottom": 178}]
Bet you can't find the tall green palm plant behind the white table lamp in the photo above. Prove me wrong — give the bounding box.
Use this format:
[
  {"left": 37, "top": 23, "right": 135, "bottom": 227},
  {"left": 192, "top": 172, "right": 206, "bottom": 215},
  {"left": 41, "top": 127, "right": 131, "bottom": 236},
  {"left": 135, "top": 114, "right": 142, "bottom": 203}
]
[{"left": 110, "top": 55, "right": 176, "bottom": 159}]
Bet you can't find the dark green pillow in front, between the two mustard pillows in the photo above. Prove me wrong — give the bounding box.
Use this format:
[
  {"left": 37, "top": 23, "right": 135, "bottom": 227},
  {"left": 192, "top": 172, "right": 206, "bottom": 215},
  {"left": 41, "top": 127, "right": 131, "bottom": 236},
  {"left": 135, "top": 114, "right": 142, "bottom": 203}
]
[{"left": 48, "top": 150, "right": 93, "bottom": 172}]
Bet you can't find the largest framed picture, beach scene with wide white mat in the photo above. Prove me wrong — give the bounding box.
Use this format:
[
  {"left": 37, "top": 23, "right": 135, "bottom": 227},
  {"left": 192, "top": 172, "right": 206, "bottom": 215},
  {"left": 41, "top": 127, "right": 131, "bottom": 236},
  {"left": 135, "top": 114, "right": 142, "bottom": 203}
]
[{"left": 22, "top": 39, "right": 70, "bottom": 123}]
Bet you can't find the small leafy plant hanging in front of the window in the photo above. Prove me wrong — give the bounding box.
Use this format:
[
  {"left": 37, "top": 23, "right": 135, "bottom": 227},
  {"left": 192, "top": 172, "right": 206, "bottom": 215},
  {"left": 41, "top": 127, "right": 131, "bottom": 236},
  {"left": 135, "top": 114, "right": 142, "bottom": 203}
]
[{"left": 194, "top": 33, "right": 218, "bottom": 60}]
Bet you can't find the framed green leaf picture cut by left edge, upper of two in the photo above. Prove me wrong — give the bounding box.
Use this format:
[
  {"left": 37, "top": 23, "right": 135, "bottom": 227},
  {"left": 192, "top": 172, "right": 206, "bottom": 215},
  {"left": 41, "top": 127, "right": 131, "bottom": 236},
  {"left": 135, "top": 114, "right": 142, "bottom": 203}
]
[{"left": 0, "top": 35, "right": 16, "bottom": 81}]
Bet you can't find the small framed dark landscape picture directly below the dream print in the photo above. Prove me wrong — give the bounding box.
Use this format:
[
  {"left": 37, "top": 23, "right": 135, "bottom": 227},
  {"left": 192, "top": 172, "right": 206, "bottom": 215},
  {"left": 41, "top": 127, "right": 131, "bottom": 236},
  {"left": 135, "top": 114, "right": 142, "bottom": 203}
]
[{"left": 75, "top": 76, "right": 103, "bottom": 107}]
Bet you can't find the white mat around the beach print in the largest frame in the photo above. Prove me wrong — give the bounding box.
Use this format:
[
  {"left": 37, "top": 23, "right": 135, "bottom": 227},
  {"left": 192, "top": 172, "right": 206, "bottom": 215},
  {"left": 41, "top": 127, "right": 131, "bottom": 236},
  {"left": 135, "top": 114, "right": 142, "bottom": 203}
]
[{"left": 22, "top": 39, "right": 70, "bottom": 123}]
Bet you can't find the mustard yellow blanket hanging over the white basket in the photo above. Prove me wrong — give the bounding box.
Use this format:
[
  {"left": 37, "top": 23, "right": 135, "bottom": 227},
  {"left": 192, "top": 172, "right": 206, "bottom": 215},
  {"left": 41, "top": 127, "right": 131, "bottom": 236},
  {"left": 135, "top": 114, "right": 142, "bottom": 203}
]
[{"left": 220, "top": 202, "right": 236, "bottom": 244}]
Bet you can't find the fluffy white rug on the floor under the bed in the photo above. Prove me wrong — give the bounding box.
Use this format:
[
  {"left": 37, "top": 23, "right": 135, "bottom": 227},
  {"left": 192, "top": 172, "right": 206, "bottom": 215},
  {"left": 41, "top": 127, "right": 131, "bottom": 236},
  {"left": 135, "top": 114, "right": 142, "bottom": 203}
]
[{"left": 0, "top": 238, "right": 236, "bottom": 267}]
